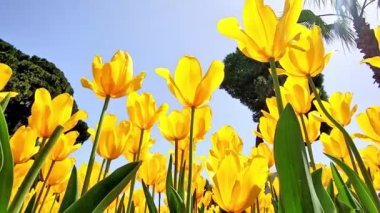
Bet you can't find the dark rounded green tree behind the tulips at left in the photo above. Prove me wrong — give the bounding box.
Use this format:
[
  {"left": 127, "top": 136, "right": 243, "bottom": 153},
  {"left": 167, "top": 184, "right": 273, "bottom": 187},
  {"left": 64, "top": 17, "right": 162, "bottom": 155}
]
[{"left": 0, "top": 39, "right": 89, "bottom": 143}]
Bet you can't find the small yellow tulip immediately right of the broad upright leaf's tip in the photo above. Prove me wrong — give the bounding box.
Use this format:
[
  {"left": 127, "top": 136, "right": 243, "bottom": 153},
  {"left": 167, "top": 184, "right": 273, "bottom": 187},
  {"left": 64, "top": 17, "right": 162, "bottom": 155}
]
[{"left": 298, "top": 111, "right": 321, "bottom": 143}]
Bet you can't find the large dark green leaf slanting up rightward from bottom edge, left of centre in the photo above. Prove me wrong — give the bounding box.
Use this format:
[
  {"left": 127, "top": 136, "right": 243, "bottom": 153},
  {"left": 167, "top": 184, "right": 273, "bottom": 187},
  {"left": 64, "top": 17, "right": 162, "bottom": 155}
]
[{"left": 65, "top": 162, "right": 141, "bottom": 213}]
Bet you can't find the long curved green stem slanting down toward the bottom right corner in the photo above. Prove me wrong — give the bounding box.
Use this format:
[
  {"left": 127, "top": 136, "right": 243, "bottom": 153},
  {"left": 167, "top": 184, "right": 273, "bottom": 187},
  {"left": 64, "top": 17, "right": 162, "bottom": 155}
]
[{"left": 308, "top": 76, "right": 380, "bottom": 209}]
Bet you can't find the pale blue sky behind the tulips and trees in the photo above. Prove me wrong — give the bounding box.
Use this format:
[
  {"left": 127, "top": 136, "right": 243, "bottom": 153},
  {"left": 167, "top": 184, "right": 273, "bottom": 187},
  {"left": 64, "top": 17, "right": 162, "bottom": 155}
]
[{"left": 0, "top": 0, "right": 380, "bottom": 170}]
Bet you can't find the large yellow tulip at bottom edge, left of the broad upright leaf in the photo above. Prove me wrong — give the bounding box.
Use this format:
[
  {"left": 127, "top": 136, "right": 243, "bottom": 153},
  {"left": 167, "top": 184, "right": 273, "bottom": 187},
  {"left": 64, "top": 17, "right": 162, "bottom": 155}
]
[{"left": 212, "top": 152, "right": 269, "bottom": 212}]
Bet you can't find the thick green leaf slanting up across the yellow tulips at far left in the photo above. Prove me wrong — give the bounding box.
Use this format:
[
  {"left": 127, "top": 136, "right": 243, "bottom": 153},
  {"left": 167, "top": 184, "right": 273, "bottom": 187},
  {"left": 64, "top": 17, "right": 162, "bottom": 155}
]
[{"left": 7, "top": 126, "right": 63, "bottom": 212}]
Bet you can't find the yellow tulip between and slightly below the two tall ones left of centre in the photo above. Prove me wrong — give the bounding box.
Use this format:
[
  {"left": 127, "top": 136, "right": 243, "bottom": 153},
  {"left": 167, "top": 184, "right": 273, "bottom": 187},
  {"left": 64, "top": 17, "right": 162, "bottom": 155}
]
[{"left": 126, "top": 92, "right": 169, "bottom": 130}]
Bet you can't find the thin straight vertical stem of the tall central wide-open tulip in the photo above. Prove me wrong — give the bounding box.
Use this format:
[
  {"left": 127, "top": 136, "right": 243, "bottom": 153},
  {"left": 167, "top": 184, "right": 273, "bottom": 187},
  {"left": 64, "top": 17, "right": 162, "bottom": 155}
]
[{"left": 186, "top": 107, "right": 195, "bottom": 213}]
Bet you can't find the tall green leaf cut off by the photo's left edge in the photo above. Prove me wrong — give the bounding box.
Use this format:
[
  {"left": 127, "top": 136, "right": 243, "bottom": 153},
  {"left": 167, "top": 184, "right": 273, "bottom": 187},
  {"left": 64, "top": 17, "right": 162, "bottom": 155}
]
[{"left": 0, "top": 106, "right": 13, "bottom": 212}]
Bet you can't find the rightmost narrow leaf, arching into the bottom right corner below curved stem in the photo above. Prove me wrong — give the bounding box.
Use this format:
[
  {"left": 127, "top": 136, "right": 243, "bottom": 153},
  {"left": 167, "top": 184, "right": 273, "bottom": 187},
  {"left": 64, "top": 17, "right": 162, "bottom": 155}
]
[{"left": 327, "top": 155, "right": 379, "bottom": 212}]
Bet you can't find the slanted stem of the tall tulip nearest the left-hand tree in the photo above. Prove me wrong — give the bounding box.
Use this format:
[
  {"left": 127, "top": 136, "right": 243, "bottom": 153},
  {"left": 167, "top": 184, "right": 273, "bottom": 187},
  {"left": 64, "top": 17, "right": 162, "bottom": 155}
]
[{"left": 81, "top": 96, "right": 111, "bottom": 195}]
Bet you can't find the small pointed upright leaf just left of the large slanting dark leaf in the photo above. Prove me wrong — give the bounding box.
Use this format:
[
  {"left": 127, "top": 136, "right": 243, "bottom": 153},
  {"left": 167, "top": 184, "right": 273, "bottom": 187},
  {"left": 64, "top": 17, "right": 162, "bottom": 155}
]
[{"left": 59, "top": 166, "right": 78, "bottom": 212}]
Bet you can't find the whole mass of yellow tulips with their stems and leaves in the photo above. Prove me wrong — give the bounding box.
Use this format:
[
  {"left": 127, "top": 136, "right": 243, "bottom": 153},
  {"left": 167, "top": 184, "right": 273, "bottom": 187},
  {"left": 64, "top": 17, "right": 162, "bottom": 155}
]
[{"left": 0, "top": 0, "right": 380, "bottom": 213}]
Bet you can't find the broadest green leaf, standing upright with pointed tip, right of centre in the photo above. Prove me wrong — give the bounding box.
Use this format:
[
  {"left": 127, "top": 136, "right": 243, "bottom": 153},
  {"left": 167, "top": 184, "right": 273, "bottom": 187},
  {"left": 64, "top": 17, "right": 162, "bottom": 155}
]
[{"left": 274, "top": 104, "right": 323, "bottom": 212}]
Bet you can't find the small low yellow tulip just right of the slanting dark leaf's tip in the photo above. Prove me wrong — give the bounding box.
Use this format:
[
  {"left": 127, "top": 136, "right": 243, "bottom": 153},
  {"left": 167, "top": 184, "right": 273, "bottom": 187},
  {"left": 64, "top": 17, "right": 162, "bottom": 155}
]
[{"left": 137, "top": 153, "right": 167, "bottom": 186}]
